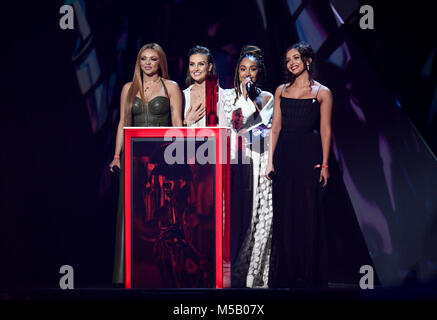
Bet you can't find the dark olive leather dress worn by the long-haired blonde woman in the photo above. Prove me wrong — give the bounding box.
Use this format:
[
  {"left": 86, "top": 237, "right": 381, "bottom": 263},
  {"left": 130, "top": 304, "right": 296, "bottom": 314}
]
[{"left": 112, "top": 79, "right": 171, "bottom": 284}]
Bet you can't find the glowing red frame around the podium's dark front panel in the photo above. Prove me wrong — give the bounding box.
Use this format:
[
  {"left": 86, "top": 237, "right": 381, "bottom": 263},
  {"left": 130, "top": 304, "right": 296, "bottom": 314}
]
[{"left": 124, "top": 127, "right": 230, "bottom": 288}]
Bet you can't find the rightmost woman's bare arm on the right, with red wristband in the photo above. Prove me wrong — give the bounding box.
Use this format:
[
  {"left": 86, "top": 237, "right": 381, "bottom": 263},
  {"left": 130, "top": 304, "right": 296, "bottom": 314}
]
[{"left": 319, "top": 87, "right": 332, "bottom": 186}]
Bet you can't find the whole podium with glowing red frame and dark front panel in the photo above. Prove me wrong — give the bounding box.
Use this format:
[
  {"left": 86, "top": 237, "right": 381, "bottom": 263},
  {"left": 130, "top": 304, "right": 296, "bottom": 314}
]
[{"left": 124, "top": 127, "right": 230, "bottom": 288}]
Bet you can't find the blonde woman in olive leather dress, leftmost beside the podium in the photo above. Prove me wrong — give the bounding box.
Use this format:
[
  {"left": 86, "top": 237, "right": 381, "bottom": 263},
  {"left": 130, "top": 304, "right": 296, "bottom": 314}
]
[{"left": 109, "top": 43, "right": 182, "bottom": 285}]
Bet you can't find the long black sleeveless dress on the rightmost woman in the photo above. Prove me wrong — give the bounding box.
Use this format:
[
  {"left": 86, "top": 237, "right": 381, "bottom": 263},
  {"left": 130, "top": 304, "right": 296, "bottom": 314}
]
[{"left": 269, "top": 97, "right": 327, "bottom": 288}]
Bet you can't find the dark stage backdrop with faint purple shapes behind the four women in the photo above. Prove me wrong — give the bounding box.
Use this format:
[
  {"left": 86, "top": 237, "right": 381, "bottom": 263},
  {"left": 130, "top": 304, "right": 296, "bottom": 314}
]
[{"left": 0, "top": 0, "right": 437, "bottom": 297}]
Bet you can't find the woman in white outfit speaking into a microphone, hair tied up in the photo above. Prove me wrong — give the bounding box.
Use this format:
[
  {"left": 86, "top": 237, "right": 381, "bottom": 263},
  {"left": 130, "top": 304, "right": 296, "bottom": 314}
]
[{"left": 219, "top": 46, "right": 274, "bottom": 288}]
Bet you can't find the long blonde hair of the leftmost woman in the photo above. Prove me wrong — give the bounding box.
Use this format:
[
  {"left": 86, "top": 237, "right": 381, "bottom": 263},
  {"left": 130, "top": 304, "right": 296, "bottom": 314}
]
[{"left": 124, "top": 43, "right": 170, "bottom": 127}]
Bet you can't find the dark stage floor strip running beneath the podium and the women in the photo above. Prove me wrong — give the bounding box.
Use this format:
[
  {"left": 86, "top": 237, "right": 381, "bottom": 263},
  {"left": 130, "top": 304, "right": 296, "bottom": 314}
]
[{"left": 0, "top": 283, "right": 437, "bottom": 303}]
